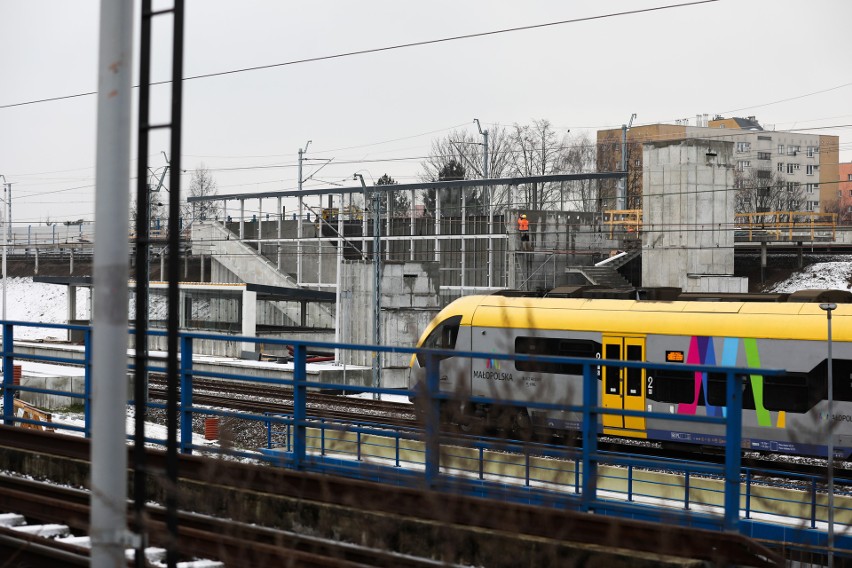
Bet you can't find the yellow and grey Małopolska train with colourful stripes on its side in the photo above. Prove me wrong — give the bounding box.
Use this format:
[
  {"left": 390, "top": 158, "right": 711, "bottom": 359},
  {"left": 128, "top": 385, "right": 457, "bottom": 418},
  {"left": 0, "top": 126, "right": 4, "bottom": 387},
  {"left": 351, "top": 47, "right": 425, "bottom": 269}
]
[{"left": 409, "top": 295, "right": 852, "bottom": 458}]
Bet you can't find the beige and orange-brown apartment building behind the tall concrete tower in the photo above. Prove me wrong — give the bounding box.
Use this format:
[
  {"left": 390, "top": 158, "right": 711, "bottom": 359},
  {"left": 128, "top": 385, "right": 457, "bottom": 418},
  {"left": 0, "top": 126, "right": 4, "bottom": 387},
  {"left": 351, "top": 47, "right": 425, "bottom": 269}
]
[{"left": 597, "top": 115, "right": 840, "bottom": 212}]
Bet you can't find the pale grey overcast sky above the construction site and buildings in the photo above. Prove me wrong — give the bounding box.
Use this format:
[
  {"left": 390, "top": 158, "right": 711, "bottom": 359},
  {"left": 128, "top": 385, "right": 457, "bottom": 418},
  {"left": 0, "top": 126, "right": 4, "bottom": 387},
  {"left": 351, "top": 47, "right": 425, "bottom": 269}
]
[{"left": 0, "top": 0, "right": 852, "bottom": 227}]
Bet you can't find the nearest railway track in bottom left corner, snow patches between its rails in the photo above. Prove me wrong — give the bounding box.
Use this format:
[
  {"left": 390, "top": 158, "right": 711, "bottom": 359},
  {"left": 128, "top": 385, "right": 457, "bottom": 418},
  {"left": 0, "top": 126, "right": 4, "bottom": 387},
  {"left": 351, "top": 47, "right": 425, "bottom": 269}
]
[{"left": 0, "top": 475, "right": 460, "bottom": 568}]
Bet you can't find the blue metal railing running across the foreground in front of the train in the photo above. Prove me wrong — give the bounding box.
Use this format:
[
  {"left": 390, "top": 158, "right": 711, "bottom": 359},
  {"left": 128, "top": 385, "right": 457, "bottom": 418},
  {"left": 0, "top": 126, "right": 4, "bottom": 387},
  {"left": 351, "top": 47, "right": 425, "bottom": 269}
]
[{"left": 2, "top": 322, "right": 852, "bottom": 548}]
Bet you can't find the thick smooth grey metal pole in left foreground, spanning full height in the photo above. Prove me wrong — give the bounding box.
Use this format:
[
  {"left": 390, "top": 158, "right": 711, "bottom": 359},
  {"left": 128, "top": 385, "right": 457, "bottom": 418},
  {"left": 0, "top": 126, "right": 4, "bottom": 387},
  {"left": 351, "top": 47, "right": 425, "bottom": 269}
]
[{"left": 90, "top": 0, "right": 133, "bottom": 568}]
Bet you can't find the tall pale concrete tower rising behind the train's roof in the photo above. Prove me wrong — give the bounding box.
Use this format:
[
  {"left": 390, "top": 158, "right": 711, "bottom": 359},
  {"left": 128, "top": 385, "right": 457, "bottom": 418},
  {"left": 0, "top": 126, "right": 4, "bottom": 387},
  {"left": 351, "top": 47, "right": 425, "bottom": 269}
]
[{"left": 642, "top": 140, "right": 748, "bottom": 292}]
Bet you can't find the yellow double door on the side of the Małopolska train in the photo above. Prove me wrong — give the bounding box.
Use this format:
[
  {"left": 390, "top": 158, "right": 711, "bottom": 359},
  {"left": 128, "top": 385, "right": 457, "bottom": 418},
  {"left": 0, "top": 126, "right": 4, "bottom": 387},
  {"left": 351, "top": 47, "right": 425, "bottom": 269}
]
[{"left": 601, "top": 335, "right": 645, "bottom": 435}]
